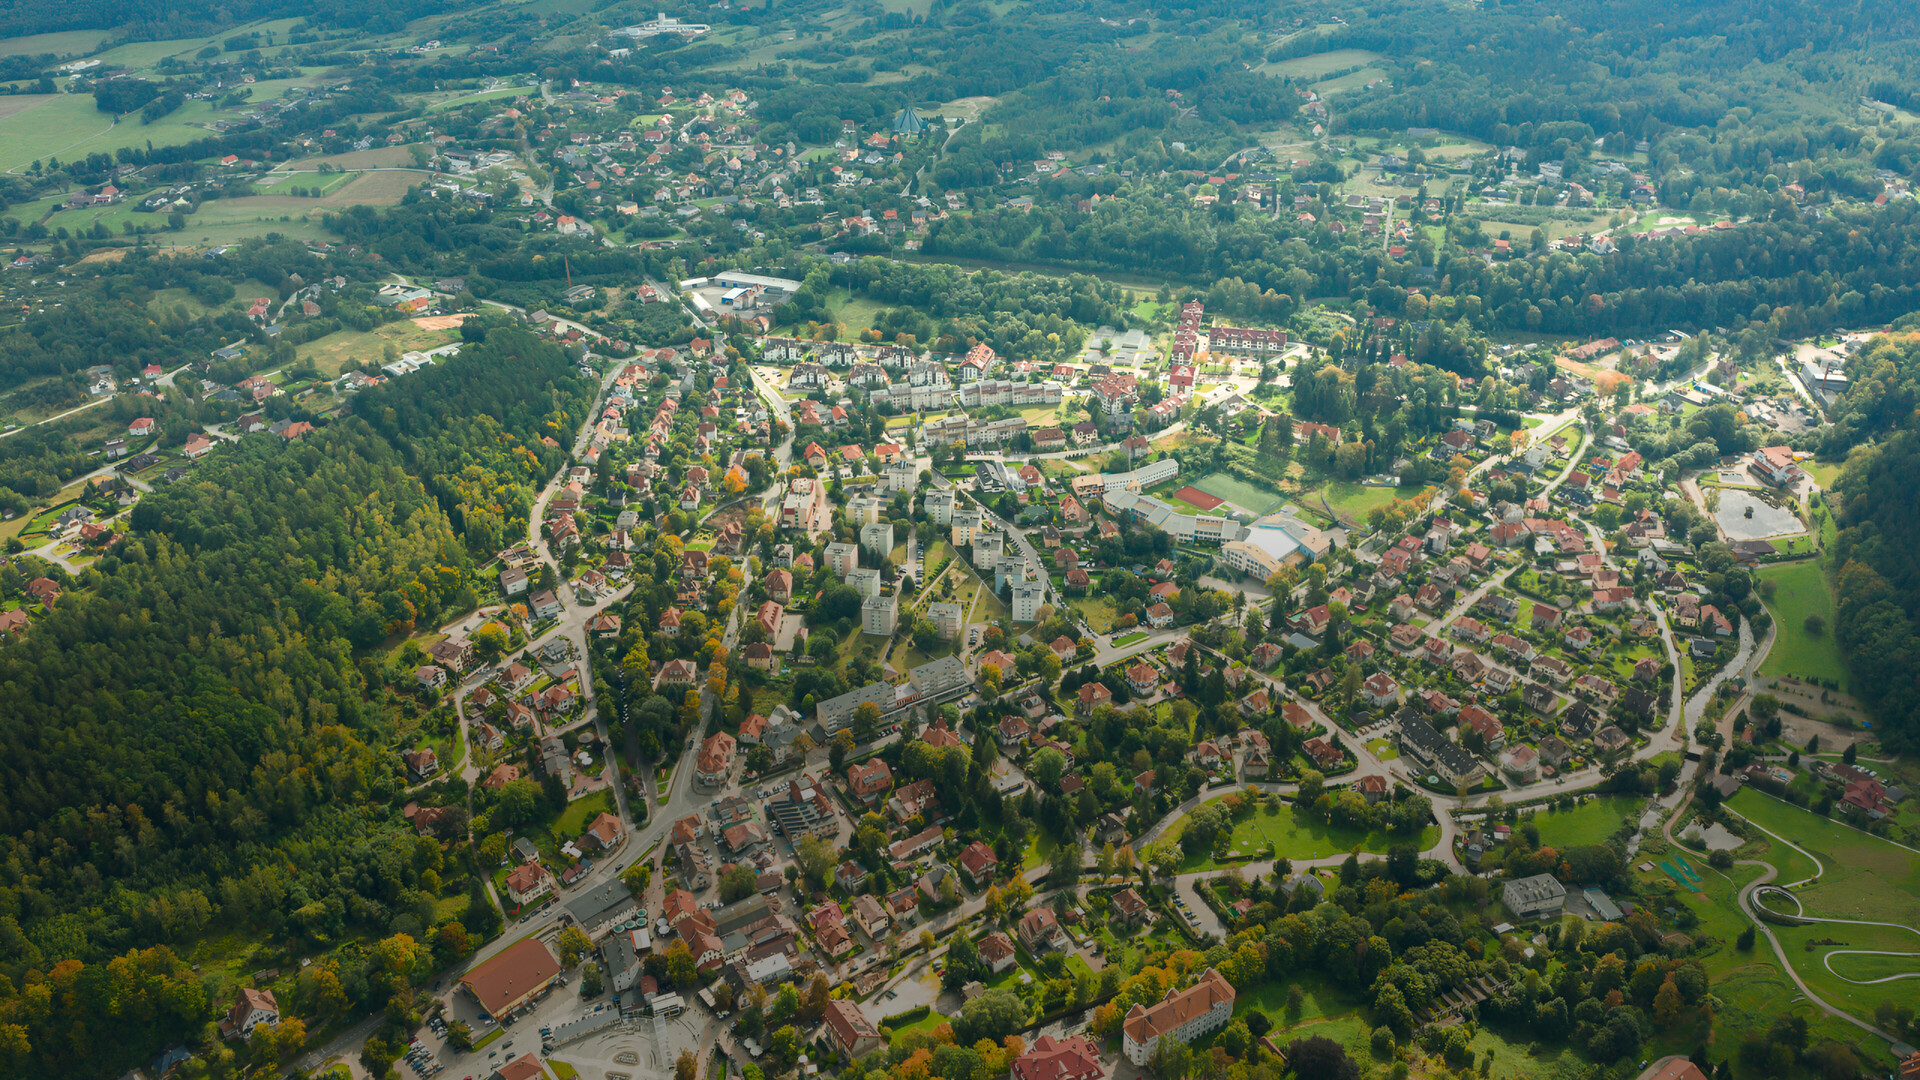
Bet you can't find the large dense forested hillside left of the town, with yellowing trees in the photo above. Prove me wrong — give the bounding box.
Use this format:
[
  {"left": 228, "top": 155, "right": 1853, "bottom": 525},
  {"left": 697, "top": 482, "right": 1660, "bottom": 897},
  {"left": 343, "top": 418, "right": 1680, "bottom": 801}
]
[{"left": 0, "top": 331, "right": 589, "bottom": 1074}]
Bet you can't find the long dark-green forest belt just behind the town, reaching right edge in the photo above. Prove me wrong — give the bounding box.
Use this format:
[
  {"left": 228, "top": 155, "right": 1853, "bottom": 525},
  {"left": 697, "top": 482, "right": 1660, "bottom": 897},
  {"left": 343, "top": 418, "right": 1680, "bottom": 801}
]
[{"left": 925, "top": 198, "right": 1920, "bottom": 336}]
